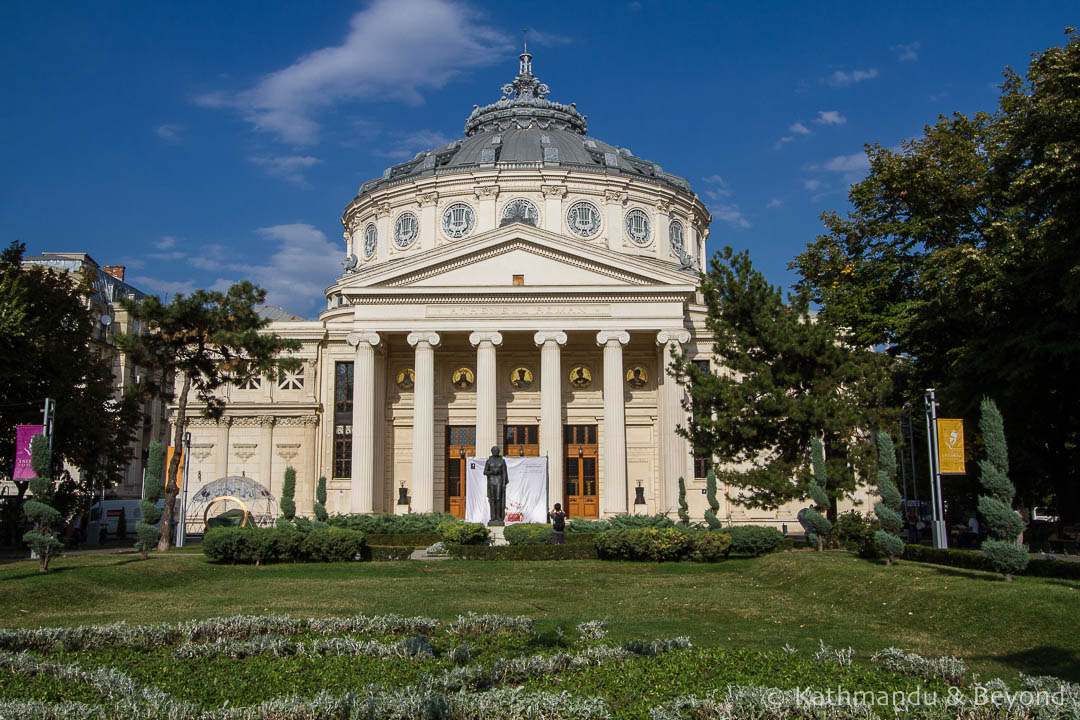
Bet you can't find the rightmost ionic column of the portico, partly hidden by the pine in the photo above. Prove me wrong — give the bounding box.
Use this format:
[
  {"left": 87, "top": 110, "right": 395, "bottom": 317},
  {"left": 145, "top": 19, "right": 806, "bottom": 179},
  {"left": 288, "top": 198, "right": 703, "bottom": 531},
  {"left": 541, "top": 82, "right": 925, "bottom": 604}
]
[{"left": 657, "top": 327, "right": 693, "bottom": 513}]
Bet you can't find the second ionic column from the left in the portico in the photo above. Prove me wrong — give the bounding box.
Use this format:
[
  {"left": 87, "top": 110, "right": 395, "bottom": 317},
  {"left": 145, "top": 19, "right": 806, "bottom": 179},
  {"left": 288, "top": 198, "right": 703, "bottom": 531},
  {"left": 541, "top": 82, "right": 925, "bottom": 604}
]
[{"left": 406, "top": 332, "right": 440, "bottom": 513}]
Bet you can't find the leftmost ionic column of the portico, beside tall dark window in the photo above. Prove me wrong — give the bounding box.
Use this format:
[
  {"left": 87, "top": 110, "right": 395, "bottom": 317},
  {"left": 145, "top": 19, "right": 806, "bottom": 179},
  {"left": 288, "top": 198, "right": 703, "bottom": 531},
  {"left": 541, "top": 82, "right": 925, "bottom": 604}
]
[{"left": 346, "top": 332, "right": 380, "bottom": 513}]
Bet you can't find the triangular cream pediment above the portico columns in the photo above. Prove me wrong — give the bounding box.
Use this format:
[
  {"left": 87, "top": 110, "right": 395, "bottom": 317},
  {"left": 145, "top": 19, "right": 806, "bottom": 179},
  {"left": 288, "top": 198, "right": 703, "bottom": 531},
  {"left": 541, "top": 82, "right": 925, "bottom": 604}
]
[{"left": 340, "top": 223, "right": 697, "bottom": 294}]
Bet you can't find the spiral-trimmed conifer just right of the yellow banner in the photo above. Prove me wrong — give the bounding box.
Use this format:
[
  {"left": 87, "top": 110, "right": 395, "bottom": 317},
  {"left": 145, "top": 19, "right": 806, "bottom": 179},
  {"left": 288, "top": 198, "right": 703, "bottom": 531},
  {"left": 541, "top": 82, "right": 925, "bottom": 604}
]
[{"left": 978, "top": 397, "right": 1028, "bottom": 581}]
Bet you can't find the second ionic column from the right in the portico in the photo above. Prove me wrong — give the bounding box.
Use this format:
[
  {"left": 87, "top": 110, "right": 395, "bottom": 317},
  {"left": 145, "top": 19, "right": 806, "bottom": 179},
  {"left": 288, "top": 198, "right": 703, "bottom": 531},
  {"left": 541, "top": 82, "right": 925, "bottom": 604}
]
[{"left": 596, "top": 330, "right": 630, "bottom": 515}]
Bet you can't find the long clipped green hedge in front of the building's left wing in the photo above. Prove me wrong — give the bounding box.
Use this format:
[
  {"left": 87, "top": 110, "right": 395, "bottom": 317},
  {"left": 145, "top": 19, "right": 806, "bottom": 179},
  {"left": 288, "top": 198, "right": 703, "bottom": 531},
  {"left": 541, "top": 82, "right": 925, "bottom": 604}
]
[{"left": 202, "top": 527, "right": 364, "bottom": 565}]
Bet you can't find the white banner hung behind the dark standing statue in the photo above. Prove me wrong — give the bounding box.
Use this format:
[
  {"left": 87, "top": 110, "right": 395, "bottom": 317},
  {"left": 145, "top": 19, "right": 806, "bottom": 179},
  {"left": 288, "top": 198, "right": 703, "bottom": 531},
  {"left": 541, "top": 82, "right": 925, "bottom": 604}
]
[{"left": 465, "top": 458, "right": 548, "bottom": 525}]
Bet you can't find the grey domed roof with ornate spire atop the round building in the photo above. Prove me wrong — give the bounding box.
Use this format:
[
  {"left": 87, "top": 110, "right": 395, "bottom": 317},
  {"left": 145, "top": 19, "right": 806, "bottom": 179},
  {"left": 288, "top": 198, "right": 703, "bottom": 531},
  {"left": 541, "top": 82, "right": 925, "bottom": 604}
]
[{"left": 356, "top": 49, "right": 690, "bottom": 196}]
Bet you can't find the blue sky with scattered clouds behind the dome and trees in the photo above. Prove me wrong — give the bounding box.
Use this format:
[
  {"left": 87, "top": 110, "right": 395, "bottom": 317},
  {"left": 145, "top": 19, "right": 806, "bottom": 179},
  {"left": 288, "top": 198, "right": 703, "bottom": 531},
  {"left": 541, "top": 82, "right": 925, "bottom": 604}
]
[{"left": 0, "top": 0, "right": 1080, "bottom": 316}]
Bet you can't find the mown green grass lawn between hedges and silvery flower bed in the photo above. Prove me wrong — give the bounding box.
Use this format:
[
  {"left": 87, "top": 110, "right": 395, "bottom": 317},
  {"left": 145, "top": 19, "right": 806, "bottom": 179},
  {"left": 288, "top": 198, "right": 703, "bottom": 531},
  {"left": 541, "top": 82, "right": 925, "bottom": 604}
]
[{"left": 0, "top": 552, "right": 1080, "bottom": 681}]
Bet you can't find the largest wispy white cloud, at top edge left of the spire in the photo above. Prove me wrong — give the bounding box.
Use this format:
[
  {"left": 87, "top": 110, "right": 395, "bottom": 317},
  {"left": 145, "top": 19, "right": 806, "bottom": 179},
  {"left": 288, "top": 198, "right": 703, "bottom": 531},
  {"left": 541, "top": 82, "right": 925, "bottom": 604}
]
[{"left": 195, "top": 0, "right": 511, "bottom": 144}]
